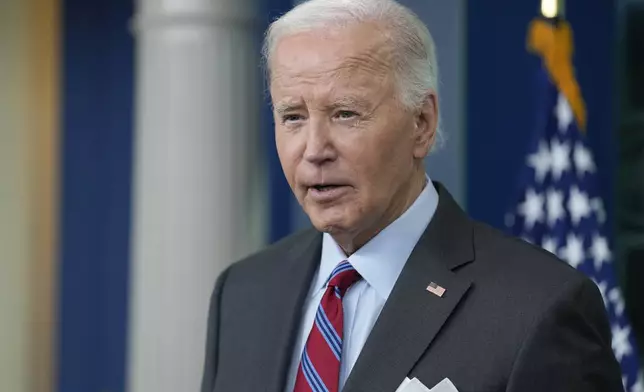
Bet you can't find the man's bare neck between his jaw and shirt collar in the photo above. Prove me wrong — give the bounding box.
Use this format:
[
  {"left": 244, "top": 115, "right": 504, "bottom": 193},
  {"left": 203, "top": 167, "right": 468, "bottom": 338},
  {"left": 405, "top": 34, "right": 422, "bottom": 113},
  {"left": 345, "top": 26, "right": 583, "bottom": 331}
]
[{"left": 331, "top": 171, "right": 427, "bottom": 256}]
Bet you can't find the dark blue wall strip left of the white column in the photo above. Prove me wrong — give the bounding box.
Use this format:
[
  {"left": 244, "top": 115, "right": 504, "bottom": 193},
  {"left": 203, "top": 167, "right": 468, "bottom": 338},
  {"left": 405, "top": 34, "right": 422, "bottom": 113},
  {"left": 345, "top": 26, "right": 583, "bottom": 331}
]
[{"left": 57, "top": 0, "right": 133, "bottom": 392}]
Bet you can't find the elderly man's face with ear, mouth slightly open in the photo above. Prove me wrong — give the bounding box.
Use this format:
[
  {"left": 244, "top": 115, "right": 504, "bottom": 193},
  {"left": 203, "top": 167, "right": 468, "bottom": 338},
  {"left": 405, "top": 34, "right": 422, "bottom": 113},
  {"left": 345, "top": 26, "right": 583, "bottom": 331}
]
[{"left": 270, "top": 24, "right": 435, "bottom": 245}]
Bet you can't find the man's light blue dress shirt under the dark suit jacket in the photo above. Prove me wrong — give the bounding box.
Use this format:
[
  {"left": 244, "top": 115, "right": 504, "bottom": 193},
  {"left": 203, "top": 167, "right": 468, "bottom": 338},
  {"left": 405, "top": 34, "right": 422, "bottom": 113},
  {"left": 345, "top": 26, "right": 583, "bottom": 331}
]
[{"left": 286, "top": 178, "right": 438, "bottom": 392}]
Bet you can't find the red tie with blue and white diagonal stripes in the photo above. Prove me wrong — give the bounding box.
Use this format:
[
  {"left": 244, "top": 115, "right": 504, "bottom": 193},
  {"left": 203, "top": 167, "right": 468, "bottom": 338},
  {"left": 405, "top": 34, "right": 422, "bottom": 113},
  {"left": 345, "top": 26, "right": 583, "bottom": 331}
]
[{"left": 294, "top": 261, "right": 360, "bottom": 392}]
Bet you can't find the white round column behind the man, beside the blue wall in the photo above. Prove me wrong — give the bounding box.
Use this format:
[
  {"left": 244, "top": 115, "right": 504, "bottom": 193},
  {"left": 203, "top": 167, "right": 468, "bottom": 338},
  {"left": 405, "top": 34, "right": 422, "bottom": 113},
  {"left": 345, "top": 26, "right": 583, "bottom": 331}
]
[{"left": 128, "top": 0, "right": 265, "bottom": 392}]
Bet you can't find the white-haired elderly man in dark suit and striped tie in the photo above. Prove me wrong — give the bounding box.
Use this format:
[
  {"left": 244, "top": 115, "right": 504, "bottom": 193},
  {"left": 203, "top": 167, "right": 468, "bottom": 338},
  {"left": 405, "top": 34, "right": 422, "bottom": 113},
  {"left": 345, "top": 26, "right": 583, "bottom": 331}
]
[{"left": 202, "top": 0, "right": 622, "bottom": 392}]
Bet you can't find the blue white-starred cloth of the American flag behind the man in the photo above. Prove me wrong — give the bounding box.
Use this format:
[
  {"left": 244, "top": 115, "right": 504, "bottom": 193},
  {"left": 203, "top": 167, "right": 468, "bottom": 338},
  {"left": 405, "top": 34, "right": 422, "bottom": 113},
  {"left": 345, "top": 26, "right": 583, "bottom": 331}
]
[{"left": 506, "top": 17, "right": 644, "bottom": 392}]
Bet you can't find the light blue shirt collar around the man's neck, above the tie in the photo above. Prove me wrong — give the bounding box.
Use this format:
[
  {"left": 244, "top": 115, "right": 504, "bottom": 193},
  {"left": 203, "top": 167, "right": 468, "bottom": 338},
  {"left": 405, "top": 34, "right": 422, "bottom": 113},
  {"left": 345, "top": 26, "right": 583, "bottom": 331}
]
[{"left": 313, "top": 177, "right": 438, "bottom": 300}]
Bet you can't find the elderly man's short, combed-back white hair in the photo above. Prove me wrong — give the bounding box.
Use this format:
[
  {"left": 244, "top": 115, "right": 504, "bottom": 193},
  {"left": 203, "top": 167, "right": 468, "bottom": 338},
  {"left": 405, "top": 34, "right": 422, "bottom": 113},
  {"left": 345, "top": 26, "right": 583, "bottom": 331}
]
[{"left": 262, "top": 0, "right": 441, "bottom": 146}]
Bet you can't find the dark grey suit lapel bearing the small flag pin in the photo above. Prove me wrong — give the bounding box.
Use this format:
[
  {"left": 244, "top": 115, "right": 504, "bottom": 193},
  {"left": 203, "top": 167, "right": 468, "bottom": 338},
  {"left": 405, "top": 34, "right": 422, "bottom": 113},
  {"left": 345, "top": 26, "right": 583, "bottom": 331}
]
[{"left": 343, "top": 184, "right": 474, "bottom": 392}]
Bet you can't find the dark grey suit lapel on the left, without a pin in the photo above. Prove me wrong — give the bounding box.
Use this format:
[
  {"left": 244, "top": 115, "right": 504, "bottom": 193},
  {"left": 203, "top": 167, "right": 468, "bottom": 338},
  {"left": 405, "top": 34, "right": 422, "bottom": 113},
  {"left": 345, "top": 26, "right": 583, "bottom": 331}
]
[{"left": 263, "top": 230, "right": 322, "bottom": 391}]
